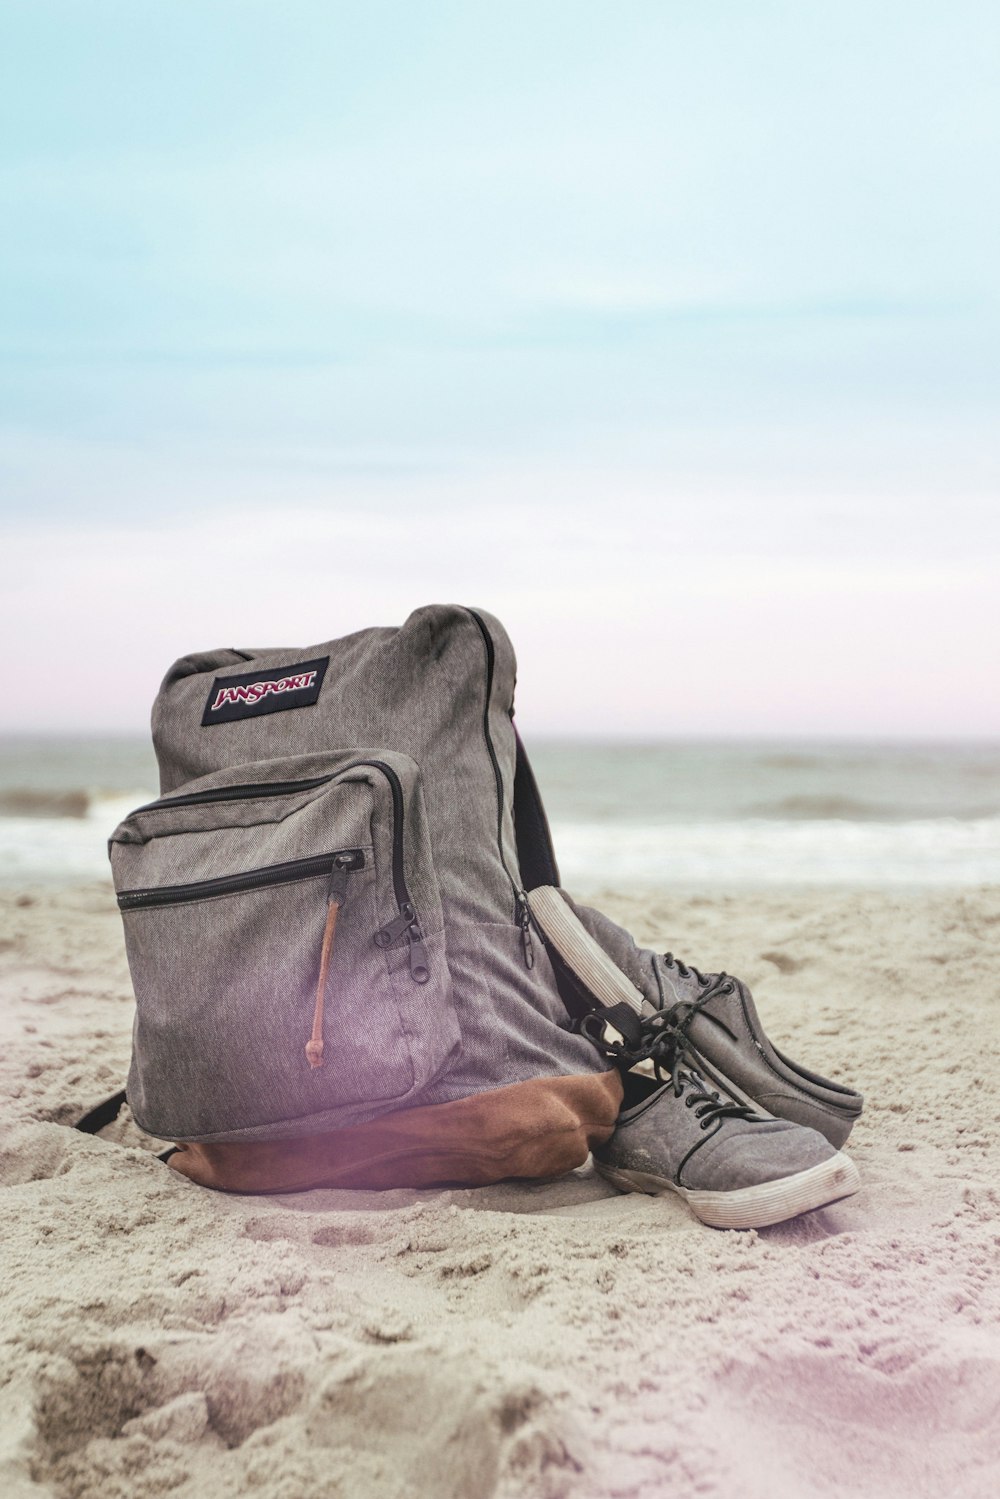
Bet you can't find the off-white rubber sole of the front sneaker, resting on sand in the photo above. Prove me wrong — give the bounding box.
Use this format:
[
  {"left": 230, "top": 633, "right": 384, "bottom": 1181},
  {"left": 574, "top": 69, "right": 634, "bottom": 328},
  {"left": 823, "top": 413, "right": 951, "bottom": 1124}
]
[{"left": 594, "top": 1151, "right": 861, "bottom": 1228}]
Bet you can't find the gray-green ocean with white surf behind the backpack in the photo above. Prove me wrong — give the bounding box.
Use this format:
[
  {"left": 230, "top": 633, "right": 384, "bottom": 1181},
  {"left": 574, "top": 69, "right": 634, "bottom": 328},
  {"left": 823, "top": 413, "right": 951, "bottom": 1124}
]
[{"left": 0, "top": 738, "right": 1000, "bottom": 890}]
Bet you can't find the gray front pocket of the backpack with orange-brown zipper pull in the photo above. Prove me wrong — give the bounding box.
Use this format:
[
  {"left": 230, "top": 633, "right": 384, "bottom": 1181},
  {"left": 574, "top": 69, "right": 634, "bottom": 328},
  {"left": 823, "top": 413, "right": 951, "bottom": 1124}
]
[{"left": 111, "top": 750, "right": 459, "bottom": 1141}]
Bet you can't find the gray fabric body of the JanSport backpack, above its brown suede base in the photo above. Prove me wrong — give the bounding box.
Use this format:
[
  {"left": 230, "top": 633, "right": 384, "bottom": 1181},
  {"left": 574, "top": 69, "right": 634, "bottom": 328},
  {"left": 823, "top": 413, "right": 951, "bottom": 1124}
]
[{"left": 93, "top": 606, "right": 611, "bottom": 1142}]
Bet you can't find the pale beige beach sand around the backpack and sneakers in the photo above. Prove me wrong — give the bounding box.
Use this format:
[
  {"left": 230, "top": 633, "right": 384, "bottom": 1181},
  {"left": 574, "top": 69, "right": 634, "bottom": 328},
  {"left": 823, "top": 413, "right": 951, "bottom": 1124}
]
[{"left": 0, "top": 884, "right": 1000, "bottom": 1499}]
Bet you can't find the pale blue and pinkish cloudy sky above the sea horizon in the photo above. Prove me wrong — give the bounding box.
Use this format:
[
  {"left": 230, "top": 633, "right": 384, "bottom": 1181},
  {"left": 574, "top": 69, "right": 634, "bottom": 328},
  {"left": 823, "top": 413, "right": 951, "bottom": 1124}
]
[{"left": 0, "top": 0, "right": 1000, "bottom": 739}]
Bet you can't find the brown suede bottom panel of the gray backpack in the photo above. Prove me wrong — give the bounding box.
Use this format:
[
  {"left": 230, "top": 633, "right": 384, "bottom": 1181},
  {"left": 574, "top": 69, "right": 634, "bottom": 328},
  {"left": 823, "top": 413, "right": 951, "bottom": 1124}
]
[{"left": 169, "top": 1072, "right": 622, "bottom": 1192}]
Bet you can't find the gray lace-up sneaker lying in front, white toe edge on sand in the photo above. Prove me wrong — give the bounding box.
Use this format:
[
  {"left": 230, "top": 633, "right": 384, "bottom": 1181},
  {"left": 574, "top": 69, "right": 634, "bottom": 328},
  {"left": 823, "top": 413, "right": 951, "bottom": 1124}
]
[{"left": 594, "top": 1016, "right": 861, "bottom": 1228}]
